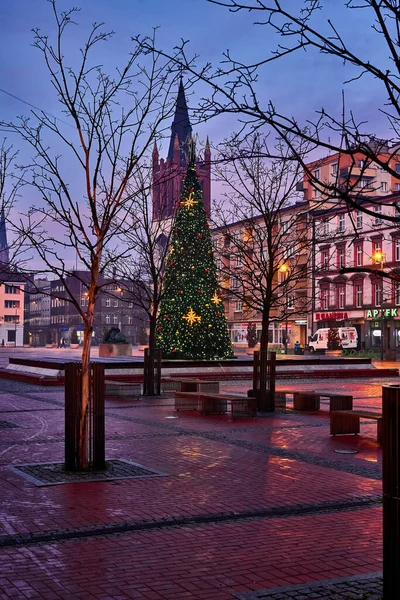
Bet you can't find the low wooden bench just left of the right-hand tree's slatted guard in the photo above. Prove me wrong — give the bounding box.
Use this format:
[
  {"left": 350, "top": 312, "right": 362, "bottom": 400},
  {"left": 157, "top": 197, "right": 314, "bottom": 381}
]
[{"left": 175, "top": 391, "right": 257, "bottom": 419}]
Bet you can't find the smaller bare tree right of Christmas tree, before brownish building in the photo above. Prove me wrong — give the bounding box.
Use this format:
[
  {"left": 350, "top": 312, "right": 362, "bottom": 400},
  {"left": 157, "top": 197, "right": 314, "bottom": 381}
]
[{"left": 215, "top": 134, "right": 312, "bottom": 410}]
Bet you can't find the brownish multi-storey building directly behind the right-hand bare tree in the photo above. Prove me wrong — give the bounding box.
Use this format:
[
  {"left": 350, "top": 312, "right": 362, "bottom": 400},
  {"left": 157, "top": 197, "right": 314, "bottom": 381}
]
[{"left": 212, "top": 202, "right": 311, "bottom": 351}]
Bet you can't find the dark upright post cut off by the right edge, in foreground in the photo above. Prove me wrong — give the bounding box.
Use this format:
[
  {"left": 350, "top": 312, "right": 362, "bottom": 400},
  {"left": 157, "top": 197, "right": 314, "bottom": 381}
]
[{"left": 382, "top": 385, "right": 400, "bottom": 600}]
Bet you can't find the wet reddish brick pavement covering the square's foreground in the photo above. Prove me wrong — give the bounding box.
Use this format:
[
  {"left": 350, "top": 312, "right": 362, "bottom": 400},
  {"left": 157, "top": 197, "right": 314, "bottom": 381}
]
[{"left": 0, "top": 381, "right": 390, "bottom": 600}]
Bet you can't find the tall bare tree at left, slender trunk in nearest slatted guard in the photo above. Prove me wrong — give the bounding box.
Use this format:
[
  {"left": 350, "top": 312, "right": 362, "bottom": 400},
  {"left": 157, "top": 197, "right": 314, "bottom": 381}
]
[{"left": 3, "top": 0, "right": 175, "bottom": 469}]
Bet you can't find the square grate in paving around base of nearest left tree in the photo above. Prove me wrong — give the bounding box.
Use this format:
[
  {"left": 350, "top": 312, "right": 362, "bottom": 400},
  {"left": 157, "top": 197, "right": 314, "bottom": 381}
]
[{"left": 8, "top": 459, "right": 165, "bottom": 487}]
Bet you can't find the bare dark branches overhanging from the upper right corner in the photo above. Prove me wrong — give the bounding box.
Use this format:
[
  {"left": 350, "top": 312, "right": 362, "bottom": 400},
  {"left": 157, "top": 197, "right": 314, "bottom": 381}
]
[{"left": 144, "top": 0, "right": 400, "bottom": 223}]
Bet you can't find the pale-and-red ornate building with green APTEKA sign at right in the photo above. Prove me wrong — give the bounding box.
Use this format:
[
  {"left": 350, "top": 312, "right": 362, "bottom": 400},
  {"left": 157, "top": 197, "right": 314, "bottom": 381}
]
[{"left": 309, "top": 194, "right": 400, "bottom": 358}]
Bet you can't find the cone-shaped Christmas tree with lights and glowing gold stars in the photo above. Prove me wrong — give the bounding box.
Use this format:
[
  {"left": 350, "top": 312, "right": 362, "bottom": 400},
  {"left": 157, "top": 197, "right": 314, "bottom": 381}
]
[{"left": 157, "top": 156, "right": 233, "bottom": 359}]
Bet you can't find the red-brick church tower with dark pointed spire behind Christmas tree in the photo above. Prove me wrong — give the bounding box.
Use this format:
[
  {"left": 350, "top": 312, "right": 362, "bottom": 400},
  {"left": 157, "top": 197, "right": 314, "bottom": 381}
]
[{"left": 152, "top": 79, "right": 211, "bottom": 221}]
